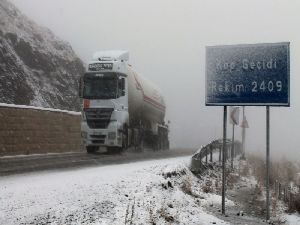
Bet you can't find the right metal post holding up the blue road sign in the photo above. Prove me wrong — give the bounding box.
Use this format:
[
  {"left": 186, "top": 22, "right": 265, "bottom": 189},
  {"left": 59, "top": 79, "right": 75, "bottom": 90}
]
[{"left": 266, "top": 106, "right": 270, "bottom": 220}]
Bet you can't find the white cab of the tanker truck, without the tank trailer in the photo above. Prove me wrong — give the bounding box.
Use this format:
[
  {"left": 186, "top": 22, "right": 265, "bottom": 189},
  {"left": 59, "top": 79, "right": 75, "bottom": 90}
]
[{"left": 80, "top": 51, "right": 129, "bottom": 152}]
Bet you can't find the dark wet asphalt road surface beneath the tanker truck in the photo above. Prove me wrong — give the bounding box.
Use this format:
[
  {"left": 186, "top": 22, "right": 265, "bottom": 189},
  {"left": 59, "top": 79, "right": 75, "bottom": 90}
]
[{"left": 0, "top": 148, "right": 196, "bottom": 176}]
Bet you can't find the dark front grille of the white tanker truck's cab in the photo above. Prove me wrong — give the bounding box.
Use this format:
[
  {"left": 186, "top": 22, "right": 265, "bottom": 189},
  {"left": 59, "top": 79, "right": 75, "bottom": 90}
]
[{"left": 84, "top": 108, "right": 114, "bottom": 129}]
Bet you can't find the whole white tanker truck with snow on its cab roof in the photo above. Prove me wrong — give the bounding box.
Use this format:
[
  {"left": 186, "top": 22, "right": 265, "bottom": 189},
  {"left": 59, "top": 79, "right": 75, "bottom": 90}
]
[{"left": 79, "top": 50, "right": 169, "bottom": 153}]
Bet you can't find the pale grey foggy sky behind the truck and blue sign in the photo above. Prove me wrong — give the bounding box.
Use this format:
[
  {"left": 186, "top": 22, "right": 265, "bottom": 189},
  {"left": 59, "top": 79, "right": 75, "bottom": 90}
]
[{"left": 12, "top": 0, "right": 300, "bottom": 158}]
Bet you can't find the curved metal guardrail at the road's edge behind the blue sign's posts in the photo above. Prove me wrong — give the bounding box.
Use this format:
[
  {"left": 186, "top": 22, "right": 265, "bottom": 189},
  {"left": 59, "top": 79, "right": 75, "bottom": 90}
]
[{"left": 191, "top": 139, "right": 242, "bottom": 173}]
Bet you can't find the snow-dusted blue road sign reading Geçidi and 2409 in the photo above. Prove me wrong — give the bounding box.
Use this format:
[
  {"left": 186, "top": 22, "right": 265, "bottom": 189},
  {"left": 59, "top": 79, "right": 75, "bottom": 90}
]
[{"left": 206, "top": 42, "right": 290, "bottom": 106}]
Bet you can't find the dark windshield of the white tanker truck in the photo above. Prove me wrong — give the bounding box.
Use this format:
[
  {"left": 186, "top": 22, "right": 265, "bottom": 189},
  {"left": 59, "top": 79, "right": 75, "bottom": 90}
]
[{"left": 83, "top": 73, "right": 118, "bottom": 99}]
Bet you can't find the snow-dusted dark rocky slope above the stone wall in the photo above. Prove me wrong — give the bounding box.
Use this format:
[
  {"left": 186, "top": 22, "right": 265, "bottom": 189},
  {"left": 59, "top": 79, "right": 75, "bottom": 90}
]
[{"left": 0, "top": 0, "right": 84, "bottom": 110}]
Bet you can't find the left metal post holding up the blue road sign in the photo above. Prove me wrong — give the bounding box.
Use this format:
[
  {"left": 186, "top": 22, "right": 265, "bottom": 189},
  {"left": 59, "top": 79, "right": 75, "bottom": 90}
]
[{"left": 222, "top": 106, "right": 227, "bottom": 215}]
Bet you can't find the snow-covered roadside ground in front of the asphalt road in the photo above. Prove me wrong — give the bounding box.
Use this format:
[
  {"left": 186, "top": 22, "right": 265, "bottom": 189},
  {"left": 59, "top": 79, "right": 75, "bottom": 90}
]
[{"left": 0, "top": 157, "right": 233, "bottom": 225}]
